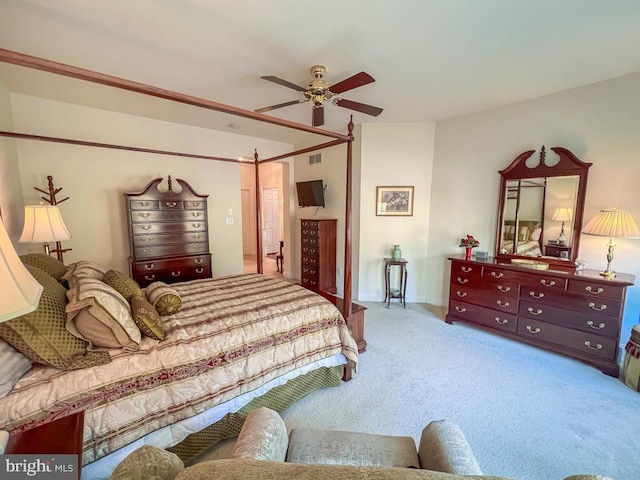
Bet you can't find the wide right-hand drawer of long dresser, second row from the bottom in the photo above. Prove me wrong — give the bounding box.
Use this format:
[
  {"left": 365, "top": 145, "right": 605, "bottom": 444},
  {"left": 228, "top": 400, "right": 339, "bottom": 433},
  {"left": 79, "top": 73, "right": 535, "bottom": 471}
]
[{"left": 518, "top": 299, "right": 620, "bottom": 339}]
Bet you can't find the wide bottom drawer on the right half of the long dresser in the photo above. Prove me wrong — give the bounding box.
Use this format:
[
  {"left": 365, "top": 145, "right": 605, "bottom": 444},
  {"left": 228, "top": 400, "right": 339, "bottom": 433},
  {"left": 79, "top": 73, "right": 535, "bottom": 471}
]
[{"left": 518, "top": 317, "right": 617, "bottom": 360}]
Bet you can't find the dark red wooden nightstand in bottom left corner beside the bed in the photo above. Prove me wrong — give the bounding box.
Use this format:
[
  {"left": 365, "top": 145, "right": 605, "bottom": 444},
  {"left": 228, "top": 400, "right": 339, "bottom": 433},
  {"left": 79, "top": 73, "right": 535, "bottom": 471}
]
[{"left": 4, "top": 412, "right": 84, "bottom": 479}]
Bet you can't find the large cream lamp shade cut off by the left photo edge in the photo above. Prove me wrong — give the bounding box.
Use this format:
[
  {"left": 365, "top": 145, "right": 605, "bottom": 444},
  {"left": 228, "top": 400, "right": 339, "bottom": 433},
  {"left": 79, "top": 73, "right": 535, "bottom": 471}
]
[{"left": 0, "top": 220, "right": 42, "bottom": 322}]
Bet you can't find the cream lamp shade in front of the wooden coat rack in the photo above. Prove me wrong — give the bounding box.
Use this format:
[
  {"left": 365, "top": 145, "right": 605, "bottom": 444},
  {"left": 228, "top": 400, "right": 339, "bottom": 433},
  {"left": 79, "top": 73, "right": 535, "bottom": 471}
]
[{"left": 19, "top": 205, "right": 71, "bottom": 243}]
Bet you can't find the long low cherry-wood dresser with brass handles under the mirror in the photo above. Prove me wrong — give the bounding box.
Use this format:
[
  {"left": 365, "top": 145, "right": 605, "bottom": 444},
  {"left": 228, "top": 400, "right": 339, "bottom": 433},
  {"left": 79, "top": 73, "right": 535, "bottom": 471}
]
[{"left": 446, "top": 258, "right": 635, "bottom": 377}]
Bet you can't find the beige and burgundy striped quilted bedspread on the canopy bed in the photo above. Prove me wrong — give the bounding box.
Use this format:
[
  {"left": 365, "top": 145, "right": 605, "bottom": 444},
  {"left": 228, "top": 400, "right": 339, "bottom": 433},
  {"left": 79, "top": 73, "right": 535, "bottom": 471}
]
[{"left": 0, "top": 274, "right": 358, "bottom": 464}]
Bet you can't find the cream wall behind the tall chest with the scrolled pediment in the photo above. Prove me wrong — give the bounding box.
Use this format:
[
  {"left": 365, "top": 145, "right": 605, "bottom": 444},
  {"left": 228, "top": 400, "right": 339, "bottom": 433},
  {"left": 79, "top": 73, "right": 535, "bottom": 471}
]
[{"left": 11, "top": 94, "right": 291, "bottom": 275}]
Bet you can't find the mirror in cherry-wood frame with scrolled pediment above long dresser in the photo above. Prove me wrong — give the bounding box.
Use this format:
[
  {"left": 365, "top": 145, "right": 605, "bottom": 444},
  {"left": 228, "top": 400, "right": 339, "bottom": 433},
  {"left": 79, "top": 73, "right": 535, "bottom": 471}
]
[{"left": 495, "top": 146, "right": 591, "bottom": 270}]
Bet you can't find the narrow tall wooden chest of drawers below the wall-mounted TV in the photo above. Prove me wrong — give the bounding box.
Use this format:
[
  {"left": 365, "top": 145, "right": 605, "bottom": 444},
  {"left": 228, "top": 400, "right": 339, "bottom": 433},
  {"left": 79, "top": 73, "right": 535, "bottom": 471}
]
[{"left": 300, "top": 219, "right": 338, "bottom": 293}]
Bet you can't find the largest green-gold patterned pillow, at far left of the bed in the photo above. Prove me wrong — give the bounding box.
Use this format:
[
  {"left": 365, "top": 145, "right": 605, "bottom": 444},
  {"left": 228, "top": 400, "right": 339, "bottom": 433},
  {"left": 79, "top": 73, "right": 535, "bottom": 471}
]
[{"left": 0, "top": 265, "right": 111, "bottom": 370}]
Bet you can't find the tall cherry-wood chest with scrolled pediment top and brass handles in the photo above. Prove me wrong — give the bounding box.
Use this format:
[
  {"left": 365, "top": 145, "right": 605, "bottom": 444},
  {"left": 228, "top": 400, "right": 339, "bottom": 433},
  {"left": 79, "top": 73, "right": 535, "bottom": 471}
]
[{"left": 124, "top": 177, "right": 211, "bottom": 287}]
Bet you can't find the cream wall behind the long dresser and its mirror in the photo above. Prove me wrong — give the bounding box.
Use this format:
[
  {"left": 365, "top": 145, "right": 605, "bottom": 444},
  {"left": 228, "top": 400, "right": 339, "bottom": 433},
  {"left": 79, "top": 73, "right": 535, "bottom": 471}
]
[{"left": 427, "top": 69, "right": 640, "bottom": 343}]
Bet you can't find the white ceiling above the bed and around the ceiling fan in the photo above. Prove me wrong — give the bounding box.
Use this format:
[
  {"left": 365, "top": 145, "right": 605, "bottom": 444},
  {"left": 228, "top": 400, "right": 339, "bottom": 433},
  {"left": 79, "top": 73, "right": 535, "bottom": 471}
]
[{"left": 0, "top": 0, "right": 640, "bottom": 142}]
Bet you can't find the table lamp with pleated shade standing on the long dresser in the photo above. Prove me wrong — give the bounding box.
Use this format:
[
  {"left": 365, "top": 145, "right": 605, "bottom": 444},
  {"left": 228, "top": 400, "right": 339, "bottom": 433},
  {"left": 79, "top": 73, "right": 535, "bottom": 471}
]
[{"left": 582, "top": 207, "right": 640, "bottom": 278}]
